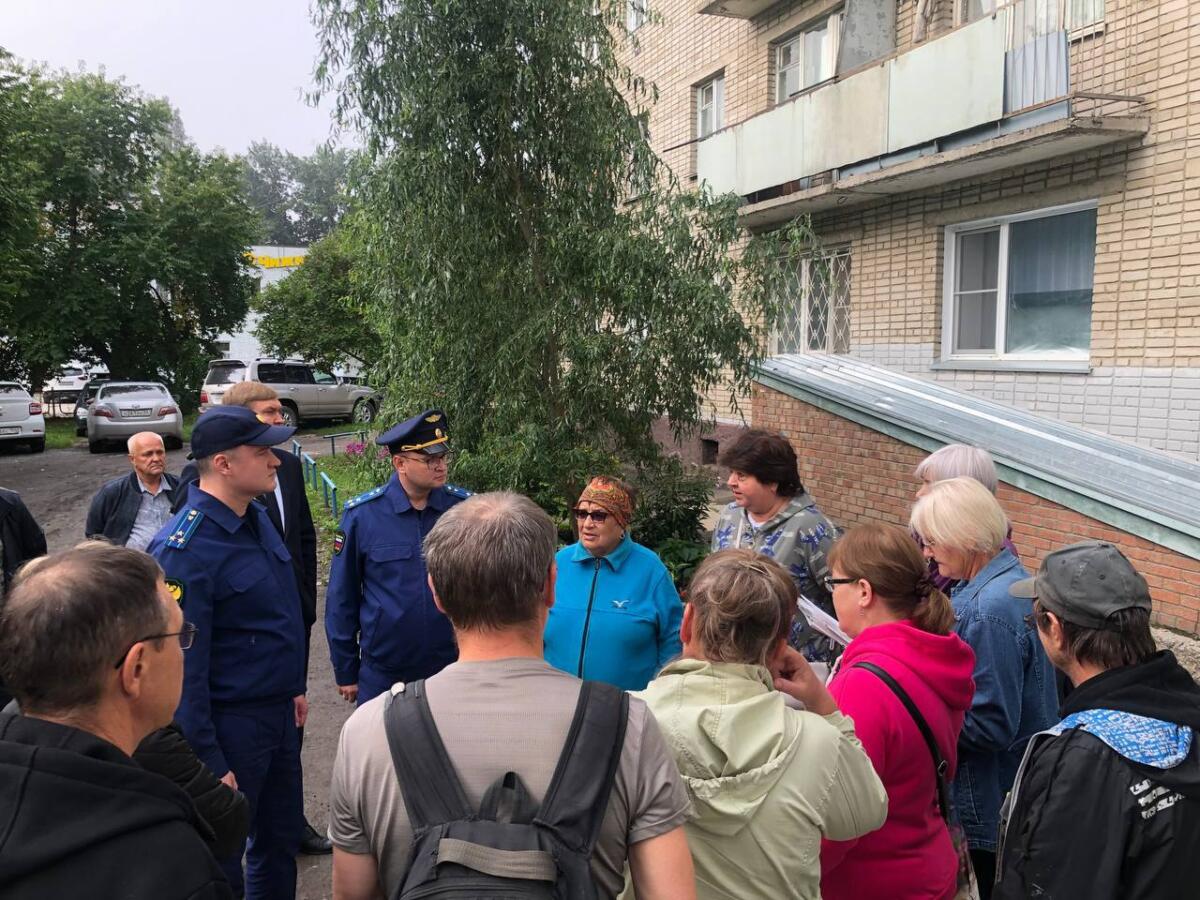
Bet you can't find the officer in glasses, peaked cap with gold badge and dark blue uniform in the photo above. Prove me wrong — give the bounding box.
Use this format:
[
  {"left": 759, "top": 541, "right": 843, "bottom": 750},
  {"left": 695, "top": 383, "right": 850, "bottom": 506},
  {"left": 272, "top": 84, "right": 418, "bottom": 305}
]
[{"left": 325, "top": 409, "right": 470, "bottom": 704}]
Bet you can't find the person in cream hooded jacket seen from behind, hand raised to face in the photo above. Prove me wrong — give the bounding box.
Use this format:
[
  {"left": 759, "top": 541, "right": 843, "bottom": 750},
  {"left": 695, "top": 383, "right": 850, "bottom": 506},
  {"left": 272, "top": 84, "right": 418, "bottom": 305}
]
[{"left": 638, "top": 550, "right": 887, "bottom": 900}]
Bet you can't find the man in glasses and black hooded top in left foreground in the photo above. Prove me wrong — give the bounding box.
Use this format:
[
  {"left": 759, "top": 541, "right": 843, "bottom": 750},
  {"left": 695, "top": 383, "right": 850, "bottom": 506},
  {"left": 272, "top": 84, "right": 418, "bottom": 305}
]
[{"left": 0, "top": 541, "right": 233, "bottom": 900}]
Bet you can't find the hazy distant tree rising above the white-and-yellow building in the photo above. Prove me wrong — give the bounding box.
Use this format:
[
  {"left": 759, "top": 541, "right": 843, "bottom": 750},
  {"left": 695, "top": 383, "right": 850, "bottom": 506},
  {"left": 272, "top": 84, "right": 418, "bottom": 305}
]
[{"left": 245, "top": 142, "right": 350, "bottom": 246}]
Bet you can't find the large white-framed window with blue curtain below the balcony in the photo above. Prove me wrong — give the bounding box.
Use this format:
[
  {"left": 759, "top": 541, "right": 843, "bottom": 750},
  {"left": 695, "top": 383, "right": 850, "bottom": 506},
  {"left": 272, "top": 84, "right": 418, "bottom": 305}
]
[{"left": 942, "top": 203, "right": 1096, "bottom": 360}]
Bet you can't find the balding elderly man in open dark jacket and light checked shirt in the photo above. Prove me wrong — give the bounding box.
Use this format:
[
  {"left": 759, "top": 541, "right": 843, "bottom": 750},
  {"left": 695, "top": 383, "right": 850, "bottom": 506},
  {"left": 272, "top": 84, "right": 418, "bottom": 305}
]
[{"left": 84, "top": 431, "right": 179, "bottom": 550}]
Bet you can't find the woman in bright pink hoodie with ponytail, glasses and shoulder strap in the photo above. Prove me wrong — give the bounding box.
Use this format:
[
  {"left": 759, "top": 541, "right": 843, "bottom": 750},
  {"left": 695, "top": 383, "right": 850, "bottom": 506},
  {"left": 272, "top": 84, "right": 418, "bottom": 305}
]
[{"left": 821, "top": 524, "right": 974, "bottom": 900}]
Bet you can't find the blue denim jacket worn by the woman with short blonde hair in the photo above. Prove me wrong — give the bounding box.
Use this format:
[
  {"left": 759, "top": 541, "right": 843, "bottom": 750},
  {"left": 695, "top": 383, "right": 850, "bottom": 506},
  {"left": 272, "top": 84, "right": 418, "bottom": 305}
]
[{"left": 950, "top": 548, "right": 1058, "bottom": 851}]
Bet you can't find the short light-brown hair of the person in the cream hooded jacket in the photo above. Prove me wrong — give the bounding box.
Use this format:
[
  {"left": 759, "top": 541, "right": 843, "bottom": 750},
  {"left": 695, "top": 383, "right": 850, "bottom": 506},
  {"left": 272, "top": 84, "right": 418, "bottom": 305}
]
[{"left": 688, "top": 550, "right": 797, "bottom": 666}]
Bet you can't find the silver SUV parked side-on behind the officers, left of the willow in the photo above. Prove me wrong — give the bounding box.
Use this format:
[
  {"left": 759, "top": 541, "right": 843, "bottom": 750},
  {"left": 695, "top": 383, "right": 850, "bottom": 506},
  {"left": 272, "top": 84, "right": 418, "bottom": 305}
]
[{"left": 200, "top": 359, "right": 380, "bottom": 427}]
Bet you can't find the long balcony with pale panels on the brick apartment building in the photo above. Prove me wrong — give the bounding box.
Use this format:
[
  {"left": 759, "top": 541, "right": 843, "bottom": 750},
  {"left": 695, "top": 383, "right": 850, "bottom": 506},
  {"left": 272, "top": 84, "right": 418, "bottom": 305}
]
[{"left": 696, "top": 0, "right": 1147, "bottom": 227}]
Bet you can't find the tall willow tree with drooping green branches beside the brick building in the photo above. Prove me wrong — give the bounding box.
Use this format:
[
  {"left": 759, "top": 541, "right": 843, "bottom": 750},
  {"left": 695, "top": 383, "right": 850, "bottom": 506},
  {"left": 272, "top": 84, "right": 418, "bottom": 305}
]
[{"left": 314, "top": 0, "right": 801, "bottom": 487}]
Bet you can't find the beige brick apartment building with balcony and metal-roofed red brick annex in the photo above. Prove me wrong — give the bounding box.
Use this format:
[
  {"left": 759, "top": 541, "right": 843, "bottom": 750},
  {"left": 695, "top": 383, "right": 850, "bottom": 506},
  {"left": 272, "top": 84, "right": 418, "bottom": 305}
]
[{"left": 625, "top": 0, "right": 1200, "bottom": 631}]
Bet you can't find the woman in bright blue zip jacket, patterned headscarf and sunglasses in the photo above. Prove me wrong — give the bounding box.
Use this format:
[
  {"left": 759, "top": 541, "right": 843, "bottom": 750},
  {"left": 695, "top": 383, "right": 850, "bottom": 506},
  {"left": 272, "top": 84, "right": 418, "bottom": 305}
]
[{"left": 545, "top": 476, "right": 683, "bottom": 691}]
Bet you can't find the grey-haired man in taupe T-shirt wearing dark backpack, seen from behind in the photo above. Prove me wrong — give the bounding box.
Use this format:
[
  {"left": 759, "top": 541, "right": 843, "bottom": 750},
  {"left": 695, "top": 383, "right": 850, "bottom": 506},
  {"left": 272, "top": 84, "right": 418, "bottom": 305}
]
[{"left": 329, "top": 492, "right": 696, "bottom": 900}]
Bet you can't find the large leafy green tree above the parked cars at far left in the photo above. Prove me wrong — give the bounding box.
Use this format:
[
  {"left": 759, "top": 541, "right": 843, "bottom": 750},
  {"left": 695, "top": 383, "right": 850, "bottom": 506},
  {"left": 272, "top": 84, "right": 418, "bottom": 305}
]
[{"left": 0, "top": 60, "right": 256, "bottom": 403}]
